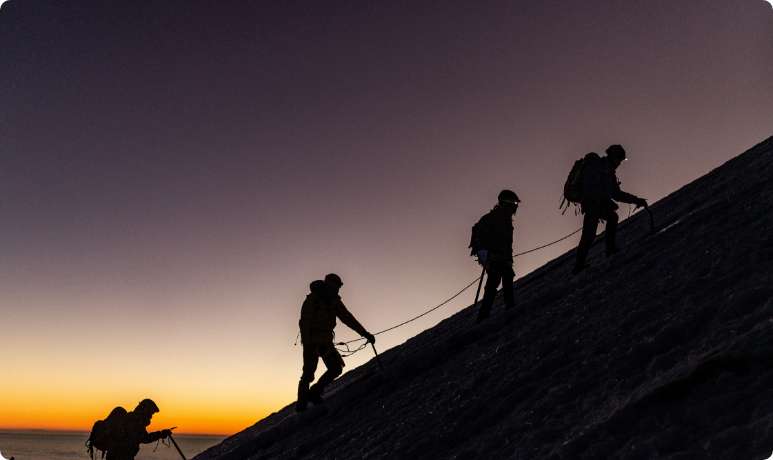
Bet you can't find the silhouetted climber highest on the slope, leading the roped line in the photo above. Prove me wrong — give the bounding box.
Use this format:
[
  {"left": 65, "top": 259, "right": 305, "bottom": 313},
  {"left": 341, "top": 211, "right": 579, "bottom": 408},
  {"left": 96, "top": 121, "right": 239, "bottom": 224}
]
[{"left": 572, "top": 144, "right": 647, "bottom": 274}]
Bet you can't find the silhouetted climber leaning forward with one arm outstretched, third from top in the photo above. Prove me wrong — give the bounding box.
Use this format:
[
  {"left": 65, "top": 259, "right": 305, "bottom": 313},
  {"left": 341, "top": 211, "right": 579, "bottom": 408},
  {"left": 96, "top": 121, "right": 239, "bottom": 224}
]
[{"left": 295, "top": 273, "right": 376, "bottom": 412}]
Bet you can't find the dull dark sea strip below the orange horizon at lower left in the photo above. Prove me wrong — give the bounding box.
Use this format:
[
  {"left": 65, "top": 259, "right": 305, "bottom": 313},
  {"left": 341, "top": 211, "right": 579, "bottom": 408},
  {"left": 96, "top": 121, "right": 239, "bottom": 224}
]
[{"left": 0, "top": 430, "right": 225, "bottom": 460}]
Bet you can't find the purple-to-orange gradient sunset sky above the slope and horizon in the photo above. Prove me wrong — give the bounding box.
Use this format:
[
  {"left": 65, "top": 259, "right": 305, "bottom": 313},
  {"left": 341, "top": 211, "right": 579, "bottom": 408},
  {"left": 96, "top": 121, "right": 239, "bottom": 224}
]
[{"left": 0, "top": 0, "right": 773, "bottom": 434}]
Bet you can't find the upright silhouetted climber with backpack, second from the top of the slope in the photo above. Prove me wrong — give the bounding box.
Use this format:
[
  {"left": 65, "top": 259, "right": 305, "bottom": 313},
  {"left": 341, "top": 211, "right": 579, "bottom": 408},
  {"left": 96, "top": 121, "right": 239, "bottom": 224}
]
[{"left": 470, "top": 190, "right": 521, "bottom": 322}]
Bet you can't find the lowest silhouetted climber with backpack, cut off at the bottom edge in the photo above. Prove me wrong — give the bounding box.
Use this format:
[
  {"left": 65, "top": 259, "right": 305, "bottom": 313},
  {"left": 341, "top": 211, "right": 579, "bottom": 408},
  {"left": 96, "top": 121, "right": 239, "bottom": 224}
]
[{"left": 86, "top": 399, "right": 172, "bottom": 460}]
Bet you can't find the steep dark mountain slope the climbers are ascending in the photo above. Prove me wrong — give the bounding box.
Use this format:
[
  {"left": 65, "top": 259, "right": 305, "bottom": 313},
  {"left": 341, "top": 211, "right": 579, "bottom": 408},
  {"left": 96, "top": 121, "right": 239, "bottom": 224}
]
[{"left": 196, "top": 138, "right": 773, "bottom": 460}]
